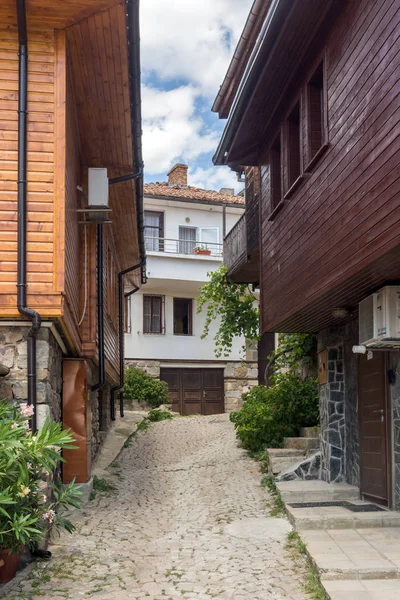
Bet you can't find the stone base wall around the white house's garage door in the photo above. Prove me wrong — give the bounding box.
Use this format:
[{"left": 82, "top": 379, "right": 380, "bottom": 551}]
[{"left": 126, "top": 360, "right": 258, "bottom": 412}]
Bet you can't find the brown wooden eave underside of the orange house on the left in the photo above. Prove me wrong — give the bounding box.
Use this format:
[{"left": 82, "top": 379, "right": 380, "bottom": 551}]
[{"left": 0, "top": 0, "right": 144, "bottom": 269}]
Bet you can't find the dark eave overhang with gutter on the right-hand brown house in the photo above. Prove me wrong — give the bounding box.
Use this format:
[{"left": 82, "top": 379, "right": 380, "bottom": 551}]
[{"left": 213, "top": 0, "right": 342, "bottom": 170}]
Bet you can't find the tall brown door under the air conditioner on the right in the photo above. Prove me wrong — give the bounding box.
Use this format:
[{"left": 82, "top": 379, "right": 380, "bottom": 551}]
[{"left": 358, "top": 352, "right": 390, "bottom": 505}]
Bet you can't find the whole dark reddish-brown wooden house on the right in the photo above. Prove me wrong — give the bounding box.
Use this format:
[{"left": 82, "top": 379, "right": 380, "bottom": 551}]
[{"left": 214, "top": 0, "right": 400, "bottom": 508}]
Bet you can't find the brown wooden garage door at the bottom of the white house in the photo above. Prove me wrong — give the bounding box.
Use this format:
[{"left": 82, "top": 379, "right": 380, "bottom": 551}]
[{"left": 161, "top": 368, "right": 224, "bottom": 415}]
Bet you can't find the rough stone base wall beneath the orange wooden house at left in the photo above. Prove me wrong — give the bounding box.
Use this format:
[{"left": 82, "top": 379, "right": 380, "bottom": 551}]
[{"left": 0, "top": 325, "right": 62, "bottom": 427}]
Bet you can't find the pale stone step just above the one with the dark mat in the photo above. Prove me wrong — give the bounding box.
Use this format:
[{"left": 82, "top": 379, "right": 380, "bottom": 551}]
[{"left": 276, "top": 479, "right": 360, "bottom": 504}]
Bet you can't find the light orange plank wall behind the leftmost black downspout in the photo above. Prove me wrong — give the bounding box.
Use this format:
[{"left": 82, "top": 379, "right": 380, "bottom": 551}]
[{"left": 0, "top": 25, "right": 61, "bottom": 317}]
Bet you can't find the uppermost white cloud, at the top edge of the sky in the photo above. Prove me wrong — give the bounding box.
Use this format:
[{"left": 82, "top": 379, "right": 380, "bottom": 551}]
[{"left": 141, "top": 0, "right": 252, "bottom": 97}]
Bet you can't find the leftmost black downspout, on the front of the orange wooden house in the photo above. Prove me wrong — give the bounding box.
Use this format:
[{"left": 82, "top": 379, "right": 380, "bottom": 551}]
[{"left": 16, "top": 0, "right": 41, "bottom": 431}]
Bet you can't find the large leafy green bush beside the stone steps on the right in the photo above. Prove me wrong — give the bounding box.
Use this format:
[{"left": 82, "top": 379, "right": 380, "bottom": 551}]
[{"left": 230, "top": 373, "right": 319, "bottom": 452}]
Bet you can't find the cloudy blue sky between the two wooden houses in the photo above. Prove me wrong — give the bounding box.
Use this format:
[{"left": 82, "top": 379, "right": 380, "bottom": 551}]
[{"left": 141, "top": 0, "right": 252, "bottom": 191}]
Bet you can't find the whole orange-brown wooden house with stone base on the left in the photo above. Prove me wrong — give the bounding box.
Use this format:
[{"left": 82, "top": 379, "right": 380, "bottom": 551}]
[{"left": 0, "top": 0, "right": 144, "bottom": 478}]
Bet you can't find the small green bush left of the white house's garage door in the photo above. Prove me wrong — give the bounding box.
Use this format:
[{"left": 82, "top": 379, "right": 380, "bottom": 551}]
[{"left": 124, "top": 368, "right": 169, "bottom": 408}]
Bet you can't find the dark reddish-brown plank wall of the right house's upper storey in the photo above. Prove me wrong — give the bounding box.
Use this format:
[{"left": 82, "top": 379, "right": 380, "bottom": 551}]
[{"left": 261, "top": 0, "right": 400, "bottom": 331}]
